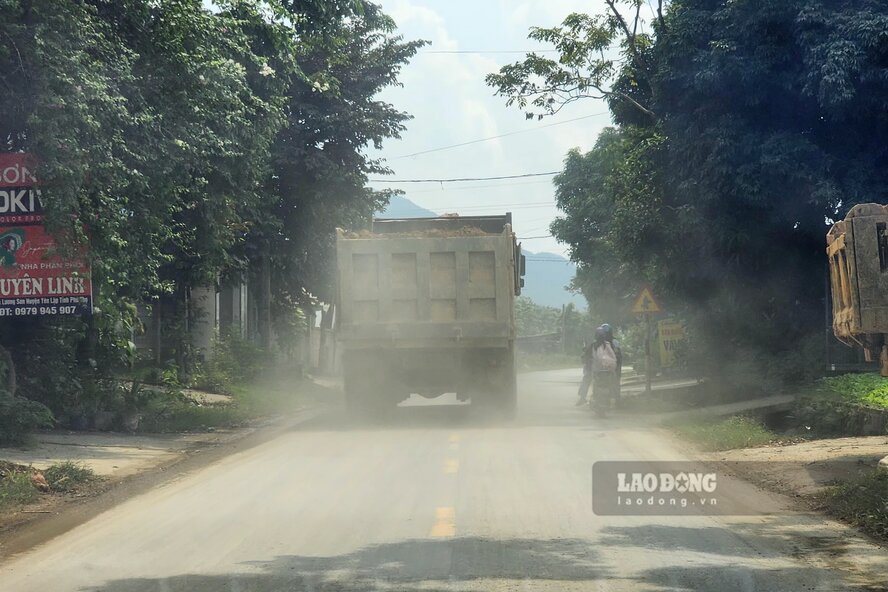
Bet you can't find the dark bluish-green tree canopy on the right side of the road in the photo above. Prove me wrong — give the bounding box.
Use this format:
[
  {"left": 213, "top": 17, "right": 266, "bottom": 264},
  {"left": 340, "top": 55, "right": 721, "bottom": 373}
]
[{"left": 489, "top": 0, "right": 888, "bottom": 390}]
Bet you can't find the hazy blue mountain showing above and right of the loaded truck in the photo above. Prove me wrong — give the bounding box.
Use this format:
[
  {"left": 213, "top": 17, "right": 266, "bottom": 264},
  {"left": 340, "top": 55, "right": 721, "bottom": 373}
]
[{"left": 379, "top": 195, "right": 586, "bottom": 310}]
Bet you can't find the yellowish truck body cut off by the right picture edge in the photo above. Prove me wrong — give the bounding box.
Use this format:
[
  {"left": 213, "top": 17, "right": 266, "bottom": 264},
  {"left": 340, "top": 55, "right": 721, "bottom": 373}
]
[{"left": 826, "top": 203, "right": 888, "bottom": 376}]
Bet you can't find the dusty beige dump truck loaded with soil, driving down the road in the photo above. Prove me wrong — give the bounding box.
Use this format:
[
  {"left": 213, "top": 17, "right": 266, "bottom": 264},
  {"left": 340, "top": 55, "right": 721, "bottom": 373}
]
[{"left": 336, "top": 214, "right": 524, "bottom": 414}]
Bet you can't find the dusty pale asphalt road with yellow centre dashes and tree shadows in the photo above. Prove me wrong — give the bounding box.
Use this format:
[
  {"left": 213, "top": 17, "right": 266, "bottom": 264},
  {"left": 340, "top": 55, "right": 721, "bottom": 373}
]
[{"left": 0, "top": 371, "right": 888, "bottom": 592}]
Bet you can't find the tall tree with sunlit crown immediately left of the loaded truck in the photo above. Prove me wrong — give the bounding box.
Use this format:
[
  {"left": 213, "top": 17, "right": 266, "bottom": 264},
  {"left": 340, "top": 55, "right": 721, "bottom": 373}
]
[{"left": 256, "top": 2, "right": 425, "bottom": 303}]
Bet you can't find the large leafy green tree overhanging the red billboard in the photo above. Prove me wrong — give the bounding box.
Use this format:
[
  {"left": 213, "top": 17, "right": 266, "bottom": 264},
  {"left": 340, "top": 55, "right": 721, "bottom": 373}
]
[{"left": 0, "top": 0, "right": 294, "bottom": 420}]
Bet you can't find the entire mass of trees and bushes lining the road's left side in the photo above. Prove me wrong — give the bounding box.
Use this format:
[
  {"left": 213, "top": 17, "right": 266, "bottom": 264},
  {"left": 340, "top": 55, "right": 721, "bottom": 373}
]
[{"left": 0, "top": 0, "right": 425, "bottom": 443}]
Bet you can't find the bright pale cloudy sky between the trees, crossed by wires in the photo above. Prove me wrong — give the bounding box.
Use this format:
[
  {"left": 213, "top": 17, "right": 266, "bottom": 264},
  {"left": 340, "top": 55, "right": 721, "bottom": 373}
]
[{"left": 374, "top": 0, "right": 610, "bottom": 253}]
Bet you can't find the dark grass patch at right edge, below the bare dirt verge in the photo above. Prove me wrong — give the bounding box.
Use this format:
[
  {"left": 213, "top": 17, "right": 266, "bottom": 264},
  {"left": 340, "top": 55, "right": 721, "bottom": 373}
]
[{"left": 820, "top": 469, "right": 888, "bottom": 540}]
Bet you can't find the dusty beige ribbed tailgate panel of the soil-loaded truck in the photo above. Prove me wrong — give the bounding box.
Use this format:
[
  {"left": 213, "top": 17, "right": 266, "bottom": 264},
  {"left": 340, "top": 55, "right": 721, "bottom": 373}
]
[{"left": 337, "top": 232, "right": 515, "bottom": 341}]
